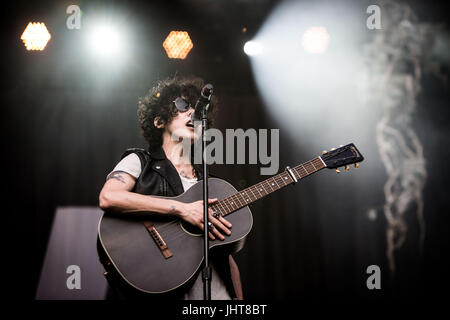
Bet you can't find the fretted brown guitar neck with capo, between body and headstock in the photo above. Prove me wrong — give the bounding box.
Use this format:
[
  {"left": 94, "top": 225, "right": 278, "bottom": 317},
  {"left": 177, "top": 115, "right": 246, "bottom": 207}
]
[{"left": 210, "top": 157, "right": 326, "bottom": 216}]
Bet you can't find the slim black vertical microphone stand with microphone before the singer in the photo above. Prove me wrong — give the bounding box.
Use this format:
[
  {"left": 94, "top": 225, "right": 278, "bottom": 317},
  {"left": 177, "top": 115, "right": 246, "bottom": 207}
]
[{"left": 201, "top": 90, "right": 212, "bottom": 300}]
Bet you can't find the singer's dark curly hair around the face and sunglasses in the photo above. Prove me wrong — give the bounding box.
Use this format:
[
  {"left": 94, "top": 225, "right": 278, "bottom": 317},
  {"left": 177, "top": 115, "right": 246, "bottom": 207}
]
[{"left": 137, "top": 77, "right": 218, "bottom": 150}]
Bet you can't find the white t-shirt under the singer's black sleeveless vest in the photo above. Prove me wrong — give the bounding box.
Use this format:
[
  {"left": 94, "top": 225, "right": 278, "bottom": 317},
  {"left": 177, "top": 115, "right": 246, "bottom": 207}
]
[{"left": 112, "top": 153, "right": 231, "bottom": 300}]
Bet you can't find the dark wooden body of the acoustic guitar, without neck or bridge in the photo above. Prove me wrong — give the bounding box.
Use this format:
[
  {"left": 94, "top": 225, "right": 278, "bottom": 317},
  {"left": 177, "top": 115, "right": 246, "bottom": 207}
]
[{"left": 98, "top": 178, "right": 253, "bottom": 294}]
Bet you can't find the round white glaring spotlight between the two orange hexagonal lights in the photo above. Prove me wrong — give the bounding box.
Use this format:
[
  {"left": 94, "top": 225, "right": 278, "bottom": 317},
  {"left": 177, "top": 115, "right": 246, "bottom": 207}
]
[{"left": 89, "top": 25, "right": 121, "bottom": 56}]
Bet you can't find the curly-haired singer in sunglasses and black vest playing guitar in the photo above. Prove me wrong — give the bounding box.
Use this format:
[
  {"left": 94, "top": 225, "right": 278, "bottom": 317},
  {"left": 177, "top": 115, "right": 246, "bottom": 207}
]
[{"left": 97, "top": 77, "right": 243, "bottom": 300}]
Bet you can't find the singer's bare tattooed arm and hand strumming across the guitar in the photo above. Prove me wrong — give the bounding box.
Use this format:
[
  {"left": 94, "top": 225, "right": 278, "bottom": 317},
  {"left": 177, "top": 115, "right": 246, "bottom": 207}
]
[{"left": 99, "top": 171, "right": 231, "bottom": 239}]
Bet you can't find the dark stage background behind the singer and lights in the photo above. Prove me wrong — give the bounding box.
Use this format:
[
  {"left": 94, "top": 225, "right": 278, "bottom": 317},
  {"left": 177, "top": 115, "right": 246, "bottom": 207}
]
[{"left": 1, "top": 0, "right": 450, "bottom": 300}]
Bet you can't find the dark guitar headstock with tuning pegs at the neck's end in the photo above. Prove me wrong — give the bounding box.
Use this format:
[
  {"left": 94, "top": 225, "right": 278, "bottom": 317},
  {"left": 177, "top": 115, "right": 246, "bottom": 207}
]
[{"left": 320, "top": 143, "right": 364, "bottom": 173}]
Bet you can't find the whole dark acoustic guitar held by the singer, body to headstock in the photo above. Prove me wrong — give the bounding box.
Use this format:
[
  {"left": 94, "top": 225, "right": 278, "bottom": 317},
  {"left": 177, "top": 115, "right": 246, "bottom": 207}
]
[{"left": 98, "top": 143, "right": 364, "bottom": 294}]
